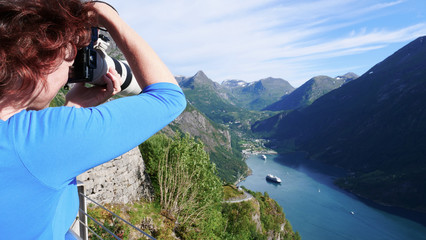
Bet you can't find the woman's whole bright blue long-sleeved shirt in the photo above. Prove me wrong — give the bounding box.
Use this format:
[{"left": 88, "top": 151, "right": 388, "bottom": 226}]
[{"left": 0, "top": 83, "right": 186, "bottom": 240}]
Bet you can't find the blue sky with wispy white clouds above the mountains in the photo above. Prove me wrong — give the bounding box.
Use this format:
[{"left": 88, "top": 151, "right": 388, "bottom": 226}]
[{"left": 107, "top": 0, "right": 426, "bottom": 87}]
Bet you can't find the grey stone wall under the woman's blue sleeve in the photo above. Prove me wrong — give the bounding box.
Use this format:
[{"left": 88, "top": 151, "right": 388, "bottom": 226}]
[{"left": 77, "top": 147, "right": 153, "bottom": 204}]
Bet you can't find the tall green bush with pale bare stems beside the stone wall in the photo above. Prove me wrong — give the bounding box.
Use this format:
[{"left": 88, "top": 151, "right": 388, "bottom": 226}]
[{"left": 141, "top": 134, "right": 223, "bottom": 237}]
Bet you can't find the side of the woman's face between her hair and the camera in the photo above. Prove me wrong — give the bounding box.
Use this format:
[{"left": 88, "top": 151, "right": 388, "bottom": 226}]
[{"left": 28, "top": 57, "right": 74, "bottom": 110}]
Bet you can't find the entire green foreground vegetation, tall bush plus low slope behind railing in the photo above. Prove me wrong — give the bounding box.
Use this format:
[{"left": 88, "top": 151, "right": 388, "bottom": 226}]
[{"left": 89, "top": 134, "right": 300, "bottom": 240}]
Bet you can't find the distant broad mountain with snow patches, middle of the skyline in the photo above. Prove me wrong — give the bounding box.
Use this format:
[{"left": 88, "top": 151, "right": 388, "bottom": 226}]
[{"left": 221, "top": 77, "right": 294, "bottom": 110}]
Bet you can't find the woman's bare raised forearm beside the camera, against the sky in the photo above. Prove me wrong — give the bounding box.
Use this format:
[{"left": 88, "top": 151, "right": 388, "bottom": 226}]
[{"left": 94, "top": 2, "right": 178, "bottom": 89}]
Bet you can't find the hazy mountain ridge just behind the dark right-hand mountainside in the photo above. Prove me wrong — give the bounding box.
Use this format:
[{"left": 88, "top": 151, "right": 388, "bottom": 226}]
[{"left": 265, "top": 73, "right": 358, "bottom": 111}]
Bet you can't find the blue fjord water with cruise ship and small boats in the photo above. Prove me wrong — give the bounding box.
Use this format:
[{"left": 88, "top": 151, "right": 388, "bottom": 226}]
[{"left": 238, "top": 153, "right": 426, "bottom": 240}]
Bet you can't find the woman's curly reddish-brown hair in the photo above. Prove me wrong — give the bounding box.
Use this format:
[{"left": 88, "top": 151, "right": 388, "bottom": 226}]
[{"left": 0, "top": 0, "right": 96, "bottom": 104}]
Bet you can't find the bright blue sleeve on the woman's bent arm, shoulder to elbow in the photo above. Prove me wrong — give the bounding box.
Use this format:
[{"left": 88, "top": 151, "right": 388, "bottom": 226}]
[{"left": 12, "top": 83, "right": 186, "bottom": 188}]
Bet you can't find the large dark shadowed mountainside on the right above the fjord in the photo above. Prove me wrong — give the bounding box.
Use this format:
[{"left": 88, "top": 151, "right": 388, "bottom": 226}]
[{"left": 253, "top": 37, "right": 426, "bottom": 212}]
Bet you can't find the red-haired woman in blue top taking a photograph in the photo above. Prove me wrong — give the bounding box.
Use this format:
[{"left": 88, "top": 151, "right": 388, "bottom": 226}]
[{"left": 0, "top": 0, "right": 186, "bottom": 239}]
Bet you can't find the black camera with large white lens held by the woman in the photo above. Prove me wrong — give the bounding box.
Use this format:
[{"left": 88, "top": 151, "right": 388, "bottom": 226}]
[{"left": 68, "top": 28, "right": 142, "bottom": 96}]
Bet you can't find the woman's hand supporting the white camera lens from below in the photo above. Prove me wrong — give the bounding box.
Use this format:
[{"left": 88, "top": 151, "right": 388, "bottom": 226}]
[{"left": 65, "top": 68, "right": 121, "bottom": 108}]
